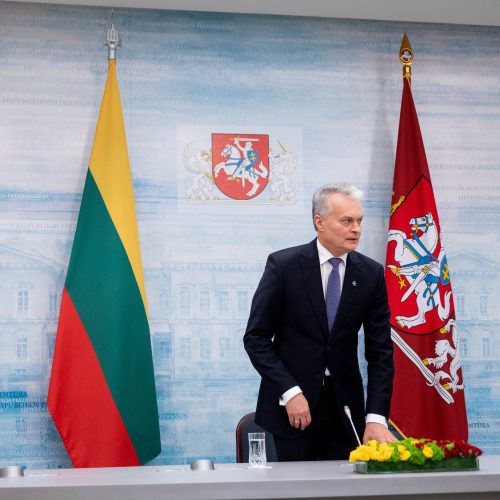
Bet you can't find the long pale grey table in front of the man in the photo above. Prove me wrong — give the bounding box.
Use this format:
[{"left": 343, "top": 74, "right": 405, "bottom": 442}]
[{"left": 0, "top": 456, "right": 500, "bottom": 500}]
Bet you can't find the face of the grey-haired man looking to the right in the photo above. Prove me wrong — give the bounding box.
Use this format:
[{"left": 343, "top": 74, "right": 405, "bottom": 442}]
[{"left": 314, "top": 193, "right": 363, "bottom": 256}]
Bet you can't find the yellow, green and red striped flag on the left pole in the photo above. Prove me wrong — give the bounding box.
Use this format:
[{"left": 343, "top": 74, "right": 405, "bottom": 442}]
[{"left": 48, "top": 60, "right": 160, "bottom": 467}]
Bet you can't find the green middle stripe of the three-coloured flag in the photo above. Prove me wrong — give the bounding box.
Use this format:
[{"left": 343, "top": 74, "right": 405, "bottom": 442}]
[{"left": 66, "top": 170, "right": 160, "bottom": 463}]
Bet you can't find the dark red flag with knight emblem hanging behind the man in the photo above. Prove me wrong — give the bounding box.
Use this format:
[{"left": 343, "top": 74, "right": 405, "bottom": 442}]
[{"left": 385, "top": 78, "right": 467, "bottom": 440}]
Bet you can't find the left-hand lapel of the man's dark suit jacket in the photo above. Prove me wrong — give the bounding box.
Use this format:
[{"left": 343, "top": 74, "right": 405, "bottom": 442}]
[{"left": 299, "top": 240, "right": 329, "bottom": 337}]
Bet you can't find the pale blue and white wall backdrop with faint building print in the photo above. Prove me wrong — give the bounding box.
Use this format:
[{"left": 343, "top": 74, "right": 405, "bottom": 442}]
[{"left": 0, "top": 2, "right": 500, "bottom": 468}]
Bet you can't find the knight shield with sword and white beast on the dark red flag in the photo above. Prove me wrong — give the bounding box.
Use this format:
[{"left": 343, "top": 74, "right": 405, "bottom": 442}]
[{"left": 386, "top": 176, "right": 464, "bottom": 404}]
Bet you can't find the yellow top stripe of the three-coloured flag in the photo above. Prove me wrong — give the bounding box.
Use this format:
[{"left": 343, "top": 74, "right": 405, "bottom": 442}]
[{"left": 89, "top": 60, "right": 147, "bottom": 313}]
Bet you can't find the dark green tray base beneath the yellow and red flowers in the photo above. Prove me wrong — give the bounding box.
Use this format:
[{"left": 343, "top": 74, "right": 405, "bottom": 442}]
[{"left": 354, "top": 457, "right": 479, "bottom": 474}]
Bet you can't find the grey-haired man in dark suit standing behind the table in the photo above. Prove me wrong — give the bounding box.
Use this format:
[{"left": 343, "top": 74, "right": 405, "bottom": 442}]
[{"left": 244, "top": 183, "right": 395, "bottom": 461}]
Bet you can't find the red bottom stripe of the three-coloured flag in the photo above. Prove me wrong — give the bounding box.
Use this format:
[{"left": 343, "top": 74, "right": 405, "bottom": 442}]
[{"left": 48, "top": 289, "right": 140, "bottom": 467}]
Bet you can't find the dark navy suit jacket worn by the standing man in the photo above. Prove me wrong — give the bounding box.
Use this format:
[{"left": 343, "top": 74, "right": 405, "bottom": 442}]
[{"left": 244, "top": 240, "right": 394, "bottom": 438}]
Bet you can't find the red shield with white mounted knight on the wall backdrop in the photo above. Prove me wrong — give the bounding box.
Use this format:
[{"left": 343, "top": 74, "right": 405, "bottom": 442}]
[{"left": 212, "top": 133, "right": 269, "bottom": 200}]
